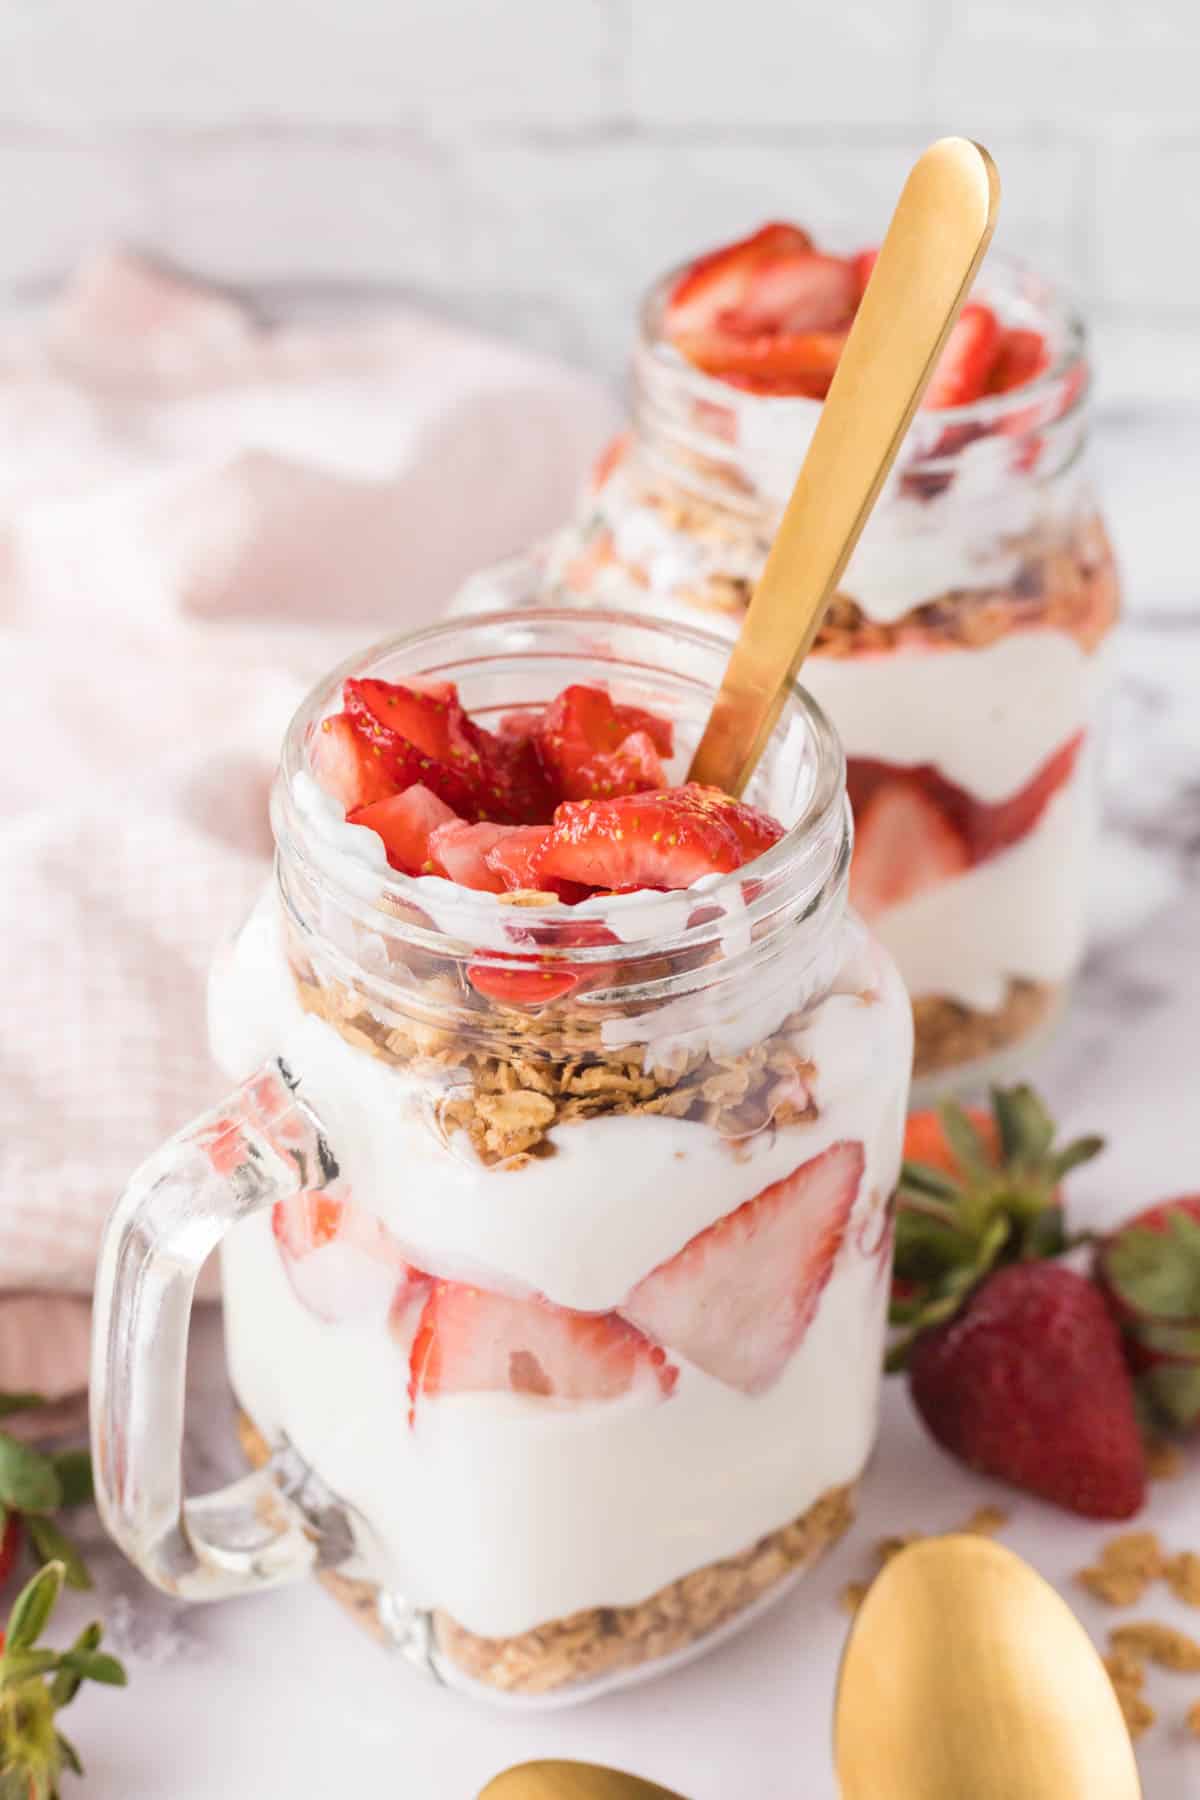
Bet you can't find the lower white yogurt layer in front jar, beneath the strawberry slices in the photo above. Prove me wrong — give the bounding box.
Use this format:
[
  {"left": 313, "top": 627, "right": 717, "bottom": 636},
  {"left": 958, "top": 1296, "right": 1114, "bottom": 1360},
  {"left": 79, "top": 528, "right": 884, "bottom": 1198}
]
[{"left": 223, "top": 1209, "right": 887, "bottom": 1636}]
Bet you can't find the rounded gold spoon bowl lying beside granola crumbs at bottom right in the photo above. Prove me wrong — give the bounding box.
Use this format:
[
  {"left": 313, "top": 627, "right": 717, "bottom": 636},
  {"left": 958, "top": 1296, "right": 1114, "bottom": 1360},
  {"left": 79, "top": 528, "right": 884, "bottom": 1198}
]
[{"left": 831, "top": 1537, "right": 1141, "bottom": 1800}]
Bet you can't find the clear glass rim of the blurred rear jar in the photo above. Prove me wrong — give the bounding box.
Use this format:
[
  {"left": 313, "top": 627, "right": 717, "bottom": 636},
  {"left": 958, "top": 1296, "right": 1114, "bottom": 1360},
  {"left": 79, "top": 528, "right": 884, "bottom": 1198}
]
[{"left": 635, "top": 252, "right": 1088, "bottom": 439}]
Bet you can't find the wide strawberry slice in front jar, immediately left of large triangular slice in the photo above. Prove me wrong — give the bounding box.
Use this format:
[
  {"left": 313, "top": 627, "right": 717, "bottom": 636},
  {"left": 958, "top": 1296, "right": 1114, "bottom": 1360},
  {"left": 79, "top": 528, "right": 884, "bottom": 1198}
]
[{"left": 408, "top": 1282, "right": 678, "bottom": 1417}]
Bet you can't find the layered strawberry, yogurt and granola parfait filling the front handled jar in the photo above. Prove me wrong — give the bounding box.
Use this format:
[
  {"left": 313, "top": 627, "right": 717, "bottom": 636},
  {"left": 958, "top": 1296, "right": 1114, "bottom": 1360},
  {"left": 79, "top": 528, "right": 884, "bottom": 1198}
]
[{"left": 210, "top": 612, "right": 910, "bottom": 1697}]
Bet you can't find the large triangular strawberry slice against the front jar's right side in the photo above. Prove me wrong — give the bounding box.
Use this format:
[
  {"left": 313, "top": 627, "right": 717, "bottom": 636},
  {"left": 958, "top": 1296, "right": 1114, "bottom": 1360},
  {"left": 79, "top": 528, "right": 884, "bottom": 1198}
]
[{"left": 621, "top": 1143, "right": 864, "bottom": 1393}]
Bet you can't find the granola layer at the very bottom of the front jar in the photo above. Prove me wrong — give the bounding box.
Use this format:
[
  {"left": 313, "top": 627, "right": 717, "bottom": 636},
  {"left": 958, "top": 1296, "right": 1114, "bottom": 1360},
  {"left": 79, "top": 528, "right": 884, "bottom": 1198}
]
[{"left": 434, "top": 1483, "right": 858, "bottom": 1694}]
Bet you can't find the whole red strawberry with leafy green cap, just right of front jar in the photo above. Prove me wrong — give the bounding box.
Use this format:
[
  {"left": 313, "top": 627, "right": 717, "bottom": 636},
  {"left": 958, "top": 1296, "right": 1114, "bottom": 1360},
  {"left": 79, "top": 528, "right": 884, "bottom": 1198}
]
[{"left": 889, "top": 1087, "right": 1144, "bottom": 1519}]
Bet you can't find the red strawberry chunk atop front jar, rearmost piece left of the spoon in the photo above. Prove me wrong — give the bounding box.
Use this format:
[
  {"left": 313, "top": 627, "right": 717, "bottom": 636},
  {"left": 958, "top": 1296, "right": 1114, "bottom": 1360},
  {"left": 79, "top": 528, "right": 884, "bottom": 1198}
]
[{"left": 534, "top": 686, "right": 675, "bottom": 799}]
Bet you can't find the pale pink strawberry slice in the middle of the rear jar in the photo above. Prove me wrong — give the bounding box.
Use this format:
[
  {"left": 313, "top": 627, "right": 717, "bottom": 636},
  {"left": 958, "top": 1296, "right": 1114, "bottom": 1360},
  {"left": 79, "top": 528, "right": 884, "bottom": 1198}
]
[{"left": 849, "top": 776, "right": 970, "bottom": 920}]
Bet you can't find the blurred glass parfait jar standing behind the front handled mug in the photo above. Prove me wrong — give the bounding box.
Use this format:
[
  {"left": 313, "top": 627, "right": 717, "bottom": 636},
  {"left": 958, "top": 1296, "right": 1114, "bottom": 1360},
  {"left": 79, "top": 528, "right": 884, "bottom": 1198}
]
[{"left": 496, "top": 257, "right": 1117, "bottom": 1085}]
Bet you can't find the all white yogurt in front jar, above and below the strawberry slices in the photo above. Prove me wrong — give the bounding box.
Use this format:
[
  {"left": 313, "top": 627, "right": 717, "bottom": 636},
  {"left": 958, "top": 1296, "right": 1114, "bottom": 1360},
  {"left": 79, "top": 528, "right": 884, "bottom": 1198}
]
[{"left": 210, "top": 896, "right": 912, "bottom": 1636}]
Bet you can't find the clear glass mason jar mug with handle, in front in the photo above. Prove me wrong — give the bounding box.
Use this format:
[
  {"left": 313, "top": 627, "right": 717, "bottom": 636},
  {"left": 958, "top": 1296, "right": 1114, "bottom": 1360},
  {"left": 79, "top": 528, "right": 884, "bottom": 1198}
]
[{"left": 95, "top": 608, "right": 912, "bottom": 1701}]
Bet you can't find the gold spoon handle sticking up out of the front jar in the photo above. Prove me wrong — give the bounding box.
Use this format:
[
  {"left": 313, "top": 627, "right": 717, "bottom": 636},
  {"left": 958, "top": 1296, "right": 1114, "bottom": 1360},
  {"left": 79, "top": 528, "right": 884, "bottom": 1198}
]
[{"left": 687, "top": 137, "right": 1000, "bottom": 796}]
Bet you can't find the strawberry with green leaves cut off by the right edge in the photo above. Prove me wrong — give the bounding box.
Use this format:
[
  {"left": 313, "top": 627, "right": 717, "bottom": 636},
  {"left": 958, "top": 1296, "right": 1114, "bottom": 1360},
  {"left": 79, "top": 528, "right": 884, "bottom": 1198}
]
[{"left": 1096, "top": 1193, "right": 1200, "bottom": 1431}]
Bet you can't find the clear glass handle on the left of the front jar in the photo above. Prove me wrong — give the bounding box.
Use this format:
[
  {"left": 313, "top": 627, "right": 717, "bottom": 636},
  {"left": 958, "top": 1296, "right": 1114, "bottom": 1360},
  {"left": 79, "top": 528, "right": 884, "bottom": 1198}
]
[{"left": 92, "top": 1060, "right": 344, "bottom": 1600}]
